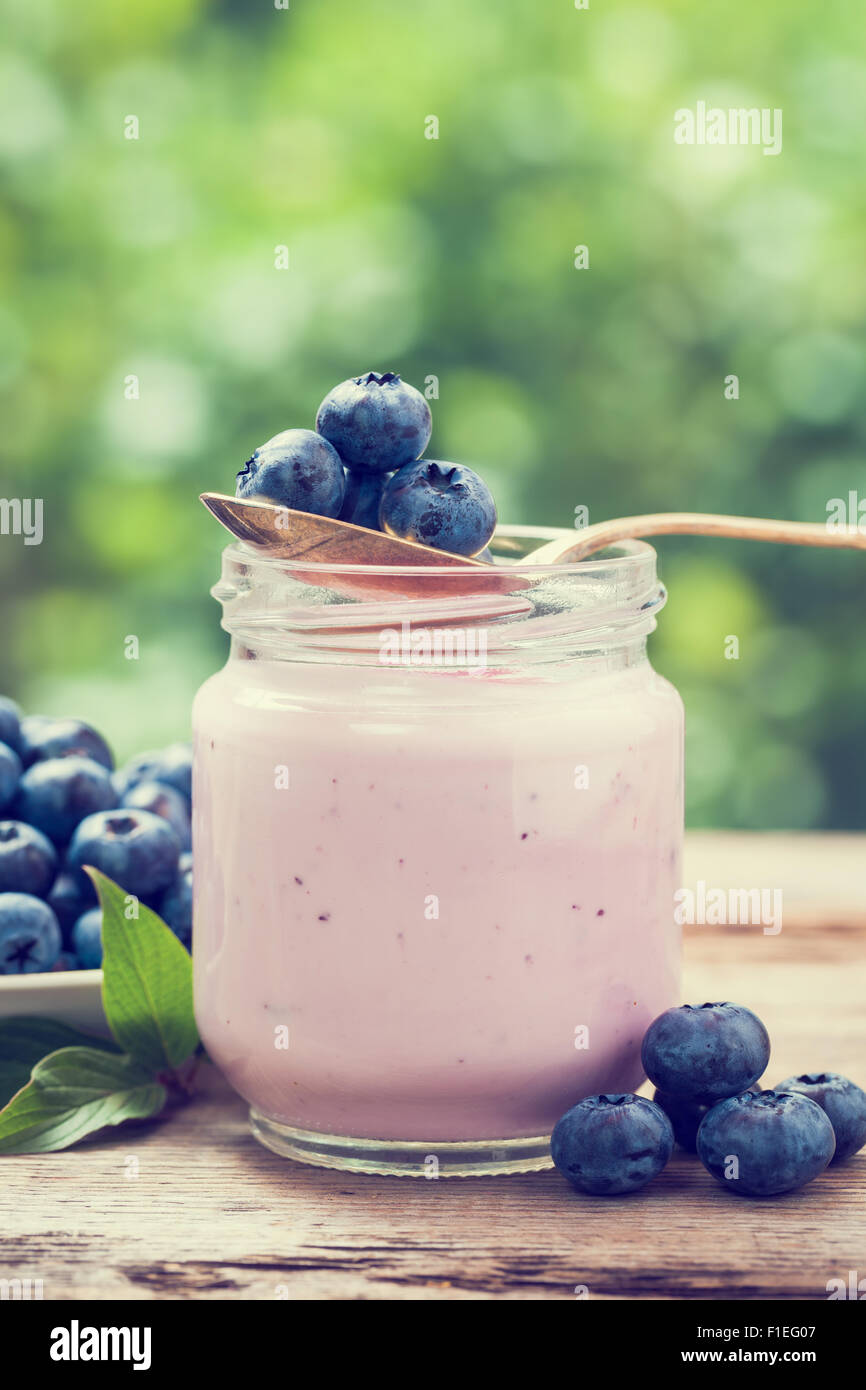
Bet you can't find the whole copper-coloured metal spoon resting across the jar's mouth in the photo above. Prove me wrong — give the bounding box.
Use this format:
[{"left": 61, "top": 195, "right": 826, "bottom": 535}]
[{"left": 202, "top": 492, "right": 866, "bottom": 569}]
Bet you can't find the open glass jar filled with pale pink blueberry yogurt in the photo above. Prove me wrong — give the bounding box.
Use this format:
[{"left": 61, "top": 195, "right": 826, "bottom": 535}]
[{"left": 193, "top": 528, "right": 683, "bottom": 1176}]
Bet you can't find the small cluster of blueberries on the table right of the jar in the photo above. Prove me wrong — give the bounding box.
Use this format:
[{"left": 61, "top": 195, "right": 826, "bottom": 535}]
[{"left": 550, "top": 1004, "right": 866, "bottom": 1197}]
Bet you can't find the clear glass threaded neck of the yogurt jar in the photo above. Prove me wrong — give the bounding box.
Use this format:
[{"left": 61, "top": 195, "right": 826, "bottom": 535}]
[{"left": 211, "top": 542, "right": 666, "bottom": 670}]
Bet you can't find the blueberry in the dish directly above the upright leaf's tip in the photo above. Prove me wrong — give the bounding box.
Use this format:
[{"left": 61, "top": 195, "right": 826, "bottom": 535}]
[{"left": 68, "top": 809, "right": 181, "bottom": 899}]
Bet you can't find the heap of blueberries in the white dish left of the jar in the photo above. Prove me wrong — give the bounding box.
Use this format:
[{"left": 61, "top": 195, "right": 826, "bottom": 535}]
[{"left": 0, "top": 696, "right": 192, "bottom": 974}]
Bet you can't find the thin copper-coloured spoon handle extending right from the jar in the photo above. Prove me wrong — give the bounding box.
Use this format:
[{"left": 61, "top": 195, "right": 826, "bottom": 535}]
[{"left": 520, "top": 512, "right": 866, "bottom": 564}]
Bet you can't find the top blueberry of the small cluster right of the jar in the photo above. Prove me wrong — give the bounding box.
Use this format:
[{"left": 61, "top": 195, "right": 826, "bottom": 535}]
[{"left": 641, "top": 1004, "right": 770, "bottom": 1105}]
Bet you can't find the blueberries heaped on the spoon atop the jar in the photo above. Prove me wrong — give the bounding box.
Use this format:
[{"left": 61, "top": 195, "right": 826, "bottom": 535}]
[{"left": 235, "top": 371, "right": 496, "bottom": 559}]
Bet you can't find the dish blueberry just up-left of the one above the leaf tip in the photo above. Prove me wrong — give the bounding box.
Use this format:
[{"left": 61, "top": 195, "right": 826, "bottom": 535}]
[{"left": 15, "top": 753, "right": 117, "bottom": 845}]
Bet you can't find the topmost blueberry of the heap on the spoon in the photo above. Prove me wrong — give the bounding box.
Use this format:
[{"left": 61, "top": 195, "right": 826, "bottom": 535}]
[{"left": 316, "top": 371, "right": 432, "bottom": 473}]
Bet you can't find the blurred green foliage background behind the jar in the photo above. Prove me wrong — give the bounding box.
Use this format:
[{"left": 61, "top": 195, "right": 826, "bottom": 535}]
[{"left": 0, "top": 0, "right": 866, "bottom": 828}]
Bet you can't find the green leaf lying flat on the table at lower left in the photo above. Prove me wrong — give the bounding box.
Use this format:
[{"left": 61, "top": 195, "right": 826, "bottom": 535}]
[{"left": 0, "top": 1047, "right": 167, "bottom": 1154}]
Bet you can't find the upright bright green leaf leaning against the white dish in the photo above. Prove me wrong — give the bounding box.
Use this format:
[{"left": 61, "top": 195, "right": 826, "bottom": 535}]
[{"left": 88, "top": 869, "right": 199, "bottom": 1072}]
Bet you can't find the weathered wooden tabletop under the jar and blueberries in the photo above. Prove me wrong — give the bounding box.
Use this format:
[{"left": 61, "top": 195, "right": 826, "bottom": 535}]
[{"left": 0, "top": 835, "right": 866, "bottom": 1300}]
